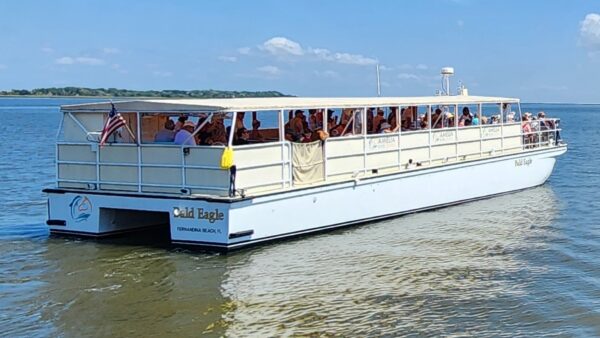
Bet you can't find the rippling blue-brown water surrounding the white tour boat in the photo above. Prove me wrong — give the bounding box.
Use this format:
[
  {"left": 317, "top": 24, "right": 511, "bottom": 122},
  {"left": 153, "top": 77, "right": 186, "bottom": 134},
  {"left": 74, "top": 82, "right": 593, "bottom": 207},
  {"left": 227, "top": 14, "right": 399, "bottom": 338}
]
[{"left": 0, "top": 98, "right": 600, "bottom": 337}]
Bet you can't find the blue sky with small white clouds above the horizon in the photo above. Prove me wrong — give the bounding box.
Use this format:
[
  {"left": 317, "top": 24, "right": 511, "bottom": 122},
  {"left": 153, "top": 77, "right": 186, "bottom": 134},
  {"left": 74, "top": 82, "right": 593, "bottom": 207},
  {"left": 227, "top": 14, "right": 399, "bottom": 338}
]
[{"left": 0, "top": 0, "right": 600, "bottom": 103}]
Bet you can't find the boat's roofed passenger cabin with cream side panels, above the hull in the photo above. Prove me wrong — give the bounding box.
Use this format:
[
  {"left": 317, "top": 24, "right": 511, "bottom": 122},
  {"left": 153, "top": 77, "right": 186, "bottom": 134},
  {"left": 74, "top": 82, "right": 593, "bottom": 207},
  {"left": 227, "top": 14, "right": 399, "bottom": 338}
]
[{"left": 56, "top": 96, "right": 559, "bottom": 200}]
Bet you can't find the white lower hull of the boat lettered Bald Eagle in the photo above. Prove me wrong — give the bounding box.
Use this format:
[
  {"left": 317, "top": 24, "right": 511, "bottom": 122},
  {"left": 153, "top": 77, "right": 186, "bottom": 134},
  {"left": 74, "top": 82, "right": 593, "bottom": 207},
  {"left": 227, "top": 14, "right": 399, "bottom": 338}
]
[{"left": 46, "top": 146, "right": 566, "bottom": 250}]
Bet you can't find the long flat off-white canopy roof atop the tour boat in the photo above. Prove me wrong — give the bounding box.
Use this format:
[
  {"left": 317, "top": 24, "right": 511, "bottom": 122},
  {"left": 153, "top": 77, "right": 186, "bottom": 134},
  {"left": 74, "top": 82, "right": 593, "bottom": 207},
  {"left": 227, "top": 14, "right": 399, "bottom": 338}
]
[{"left": 61, "top": 96, "right": 519, "bottom": 112}]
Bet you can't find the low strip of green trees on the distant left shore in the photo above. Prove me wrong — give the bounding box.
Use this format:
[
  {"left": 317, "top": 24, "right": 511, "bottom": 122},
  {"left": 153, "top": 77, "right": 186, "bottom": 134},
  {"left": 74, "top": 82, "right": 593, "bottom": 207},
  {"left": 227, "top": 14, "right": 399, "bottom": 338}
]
[{"left": 0, "top": 87, "right": 289, "bottom": 98}]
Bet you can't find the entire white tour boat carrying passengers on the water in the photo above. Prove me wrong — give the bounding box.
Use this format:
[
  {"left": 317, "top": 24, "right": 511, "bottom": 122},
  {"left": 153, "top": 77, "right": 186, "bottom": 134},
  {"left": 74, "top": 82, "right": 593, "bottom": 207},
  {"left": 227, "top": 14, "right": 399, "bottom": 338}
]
[{"left": 44, "top": 74, "right": 567, "bottom": 250}]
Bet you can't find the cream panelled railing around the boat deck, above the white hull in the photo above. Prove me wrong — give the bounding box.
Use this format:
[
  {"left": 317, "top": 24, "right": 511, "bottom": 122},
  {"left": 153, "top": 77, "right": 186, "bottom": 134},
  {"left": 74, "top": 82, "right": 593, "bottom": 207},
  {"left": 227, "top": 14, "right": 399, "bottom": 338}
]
[{"left": 56, "top": 112, "right": 561, "bottom": 197}]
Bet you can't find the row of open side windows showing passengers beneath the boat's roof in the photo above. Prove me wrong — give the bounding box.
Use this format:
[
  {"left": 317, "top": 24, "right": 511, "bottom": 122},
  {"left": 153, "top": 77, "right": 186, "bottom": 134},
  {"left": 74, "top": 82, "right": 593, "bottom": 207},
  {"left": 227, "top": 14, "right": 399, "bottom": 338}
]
[{"left": 108, "top": 104, "right": 520, "bottom": 145}]
